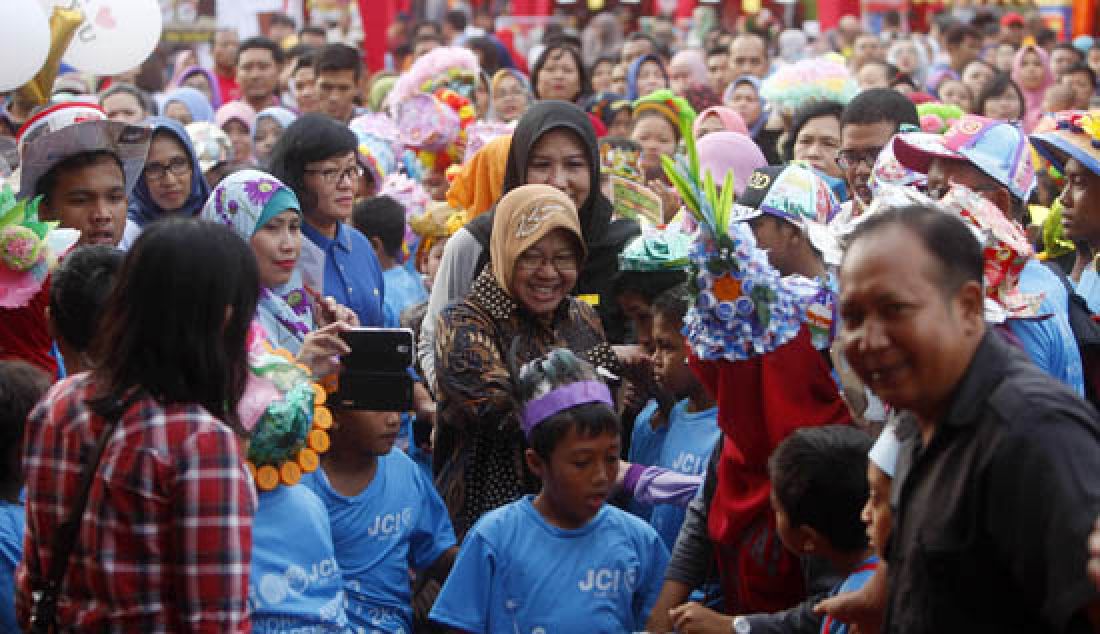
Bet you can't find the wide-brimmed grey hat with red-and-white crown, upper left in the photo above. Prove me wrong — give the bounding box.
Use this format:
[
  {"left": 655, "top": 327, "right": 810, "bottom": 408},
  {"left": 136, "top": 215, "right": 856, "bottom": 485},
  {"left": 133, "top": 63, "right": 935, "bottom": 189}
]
[{"left": 18, "top": 101, "right": 153, "bottom": 197}]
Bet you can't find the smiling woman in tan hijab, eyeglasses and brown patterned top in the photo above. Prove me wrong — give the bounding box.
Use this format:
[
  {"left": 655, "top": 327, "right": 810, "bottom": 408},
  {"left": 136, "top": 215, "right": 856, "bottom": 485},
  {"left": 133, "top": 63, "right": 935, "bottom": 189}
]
[{"left": 433, "top": 185, "right": 615, "bottom": 536}]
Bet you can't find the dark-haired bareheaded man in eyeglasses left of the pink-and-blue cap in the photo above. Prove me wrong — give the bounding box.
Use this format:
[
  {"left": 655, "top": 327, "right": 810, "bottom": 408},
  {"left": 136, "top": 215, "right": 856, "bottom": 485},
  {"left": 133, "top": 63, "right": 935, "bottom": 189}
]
[{"left": 836, "top": 88, "right": 920, "bottom": 222}]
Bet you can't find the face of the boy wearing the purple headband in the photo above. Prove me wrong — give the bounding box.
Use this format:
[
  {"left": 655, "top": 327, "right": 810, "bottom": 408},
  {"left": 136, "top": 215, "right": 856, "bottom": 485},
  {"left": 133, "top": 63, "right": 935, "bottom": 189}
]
[{"left": 528, "top": 427, "right": 619, "bottom": 527}]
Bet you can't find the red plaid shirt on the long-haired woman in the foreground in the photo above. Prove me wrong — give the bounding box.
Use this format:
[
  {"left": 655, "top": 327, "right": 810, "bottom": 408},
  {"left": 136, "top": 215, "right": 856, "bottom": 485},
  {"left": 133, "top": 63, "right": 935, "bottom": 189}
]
[{"left": 15, "top": 374, "right": 256, "bottom": 633}]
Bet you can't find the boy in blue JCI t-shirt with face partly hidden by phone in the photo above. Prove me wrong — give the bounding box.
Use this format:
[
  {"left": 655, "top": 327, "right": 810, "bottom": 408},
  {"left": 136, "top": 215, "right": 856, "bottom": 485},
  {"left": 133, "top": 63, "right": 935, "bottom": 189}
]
[{"left": 303, "top": 408, "right": 458, "bottom": 633}]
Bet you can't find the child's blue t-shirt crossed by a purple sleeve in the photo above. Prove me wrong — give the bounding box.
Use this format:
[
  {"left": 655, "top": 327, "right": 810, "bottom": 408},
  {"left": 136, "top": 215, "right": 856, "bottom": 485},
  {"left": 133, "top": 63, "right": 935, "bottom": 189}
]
[{"left": 649, "top": 398, "right": 721, "bottom": 550}]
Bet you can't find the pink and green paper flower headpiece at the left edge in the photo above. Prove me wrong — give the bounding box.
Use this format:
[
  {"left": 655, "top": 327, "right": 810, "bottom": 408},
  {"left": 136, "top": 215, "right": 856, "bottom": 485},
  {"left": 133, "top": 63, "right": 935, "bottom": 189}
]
[{"left": 0, "top": 185, "right": 80, "bottom": 308}]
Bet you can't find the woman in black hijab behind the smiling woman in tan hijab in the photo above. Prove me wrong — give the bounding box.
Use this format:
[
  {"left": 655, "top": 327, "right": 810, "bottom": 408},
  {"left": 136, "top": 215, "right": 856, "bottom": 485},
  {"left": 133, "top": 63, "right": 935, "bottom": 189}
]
[{"left": 418, "top": 101, "right": 639, "bottom": 385}]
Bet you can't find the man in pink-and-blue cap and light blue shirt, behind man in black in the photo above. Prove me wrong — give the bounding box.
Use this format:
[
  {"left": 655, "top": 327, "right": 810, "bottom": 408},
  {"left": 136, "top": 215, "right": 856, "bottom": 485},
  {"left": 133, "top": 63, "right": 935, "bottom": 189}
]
[{"left": 893, "top": 114, "right": 1085, "bottom": 395}]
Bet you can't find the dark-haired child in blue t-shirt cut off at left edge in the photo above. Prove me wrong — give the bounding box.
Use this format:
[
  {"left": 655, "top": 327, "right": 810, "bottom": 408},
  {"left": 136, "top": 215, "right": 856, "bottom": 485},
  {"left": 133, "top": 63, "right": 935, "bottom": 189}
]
[{"left": 0, "top": 361, "right": 50, "bottom": 634}]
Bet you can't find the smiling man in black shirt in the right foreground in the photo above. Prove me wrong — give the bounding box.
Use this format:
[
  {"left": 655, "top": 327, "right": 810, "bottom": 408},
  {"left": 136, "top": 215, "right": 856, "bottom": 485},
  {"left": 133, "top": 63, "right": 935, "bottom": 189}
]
[{"left": 839, "top": 207, "right": 1100, "bottom": 634}]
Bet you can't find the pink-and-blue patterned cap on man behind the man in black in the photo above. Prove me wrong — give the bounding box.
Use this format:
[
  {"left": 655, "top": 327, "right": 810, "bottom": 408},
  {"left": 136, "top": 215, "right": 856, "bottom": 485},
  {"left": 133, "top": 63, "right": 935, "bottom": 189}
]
[{"left": 893, "top": 114, "right": 1035, "bottom": 200}]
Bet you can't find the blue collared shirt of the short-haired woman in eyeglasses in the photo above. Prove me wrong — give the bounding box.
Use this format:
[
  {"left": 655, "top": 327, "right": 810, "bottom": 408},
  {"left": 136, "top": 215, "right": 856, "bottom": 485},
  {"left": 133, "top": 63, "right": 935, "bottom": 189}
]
[{"left": 301, "top": 222, "right": 385, "bottom": 327}]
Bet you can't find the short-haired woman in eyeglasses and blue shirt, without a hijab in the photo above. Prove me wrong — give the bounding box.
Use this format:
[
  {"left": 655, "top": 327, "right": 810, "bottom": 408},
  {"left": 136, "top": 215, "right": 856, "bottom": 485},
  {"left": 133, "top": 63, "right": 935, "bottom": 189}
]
[{"left": 270, "top": 113, "right": 383, "bottom": 326}]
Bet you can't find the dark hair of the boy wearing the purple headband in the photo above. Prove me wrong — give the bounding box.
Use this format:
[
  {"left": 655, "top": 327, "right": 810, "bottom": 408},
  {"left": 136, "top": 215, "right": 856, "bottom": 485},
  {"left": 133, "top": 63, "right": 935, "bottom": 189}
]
[{"left": 516, "top": 348, "right": 619, "bottom": 460}]
